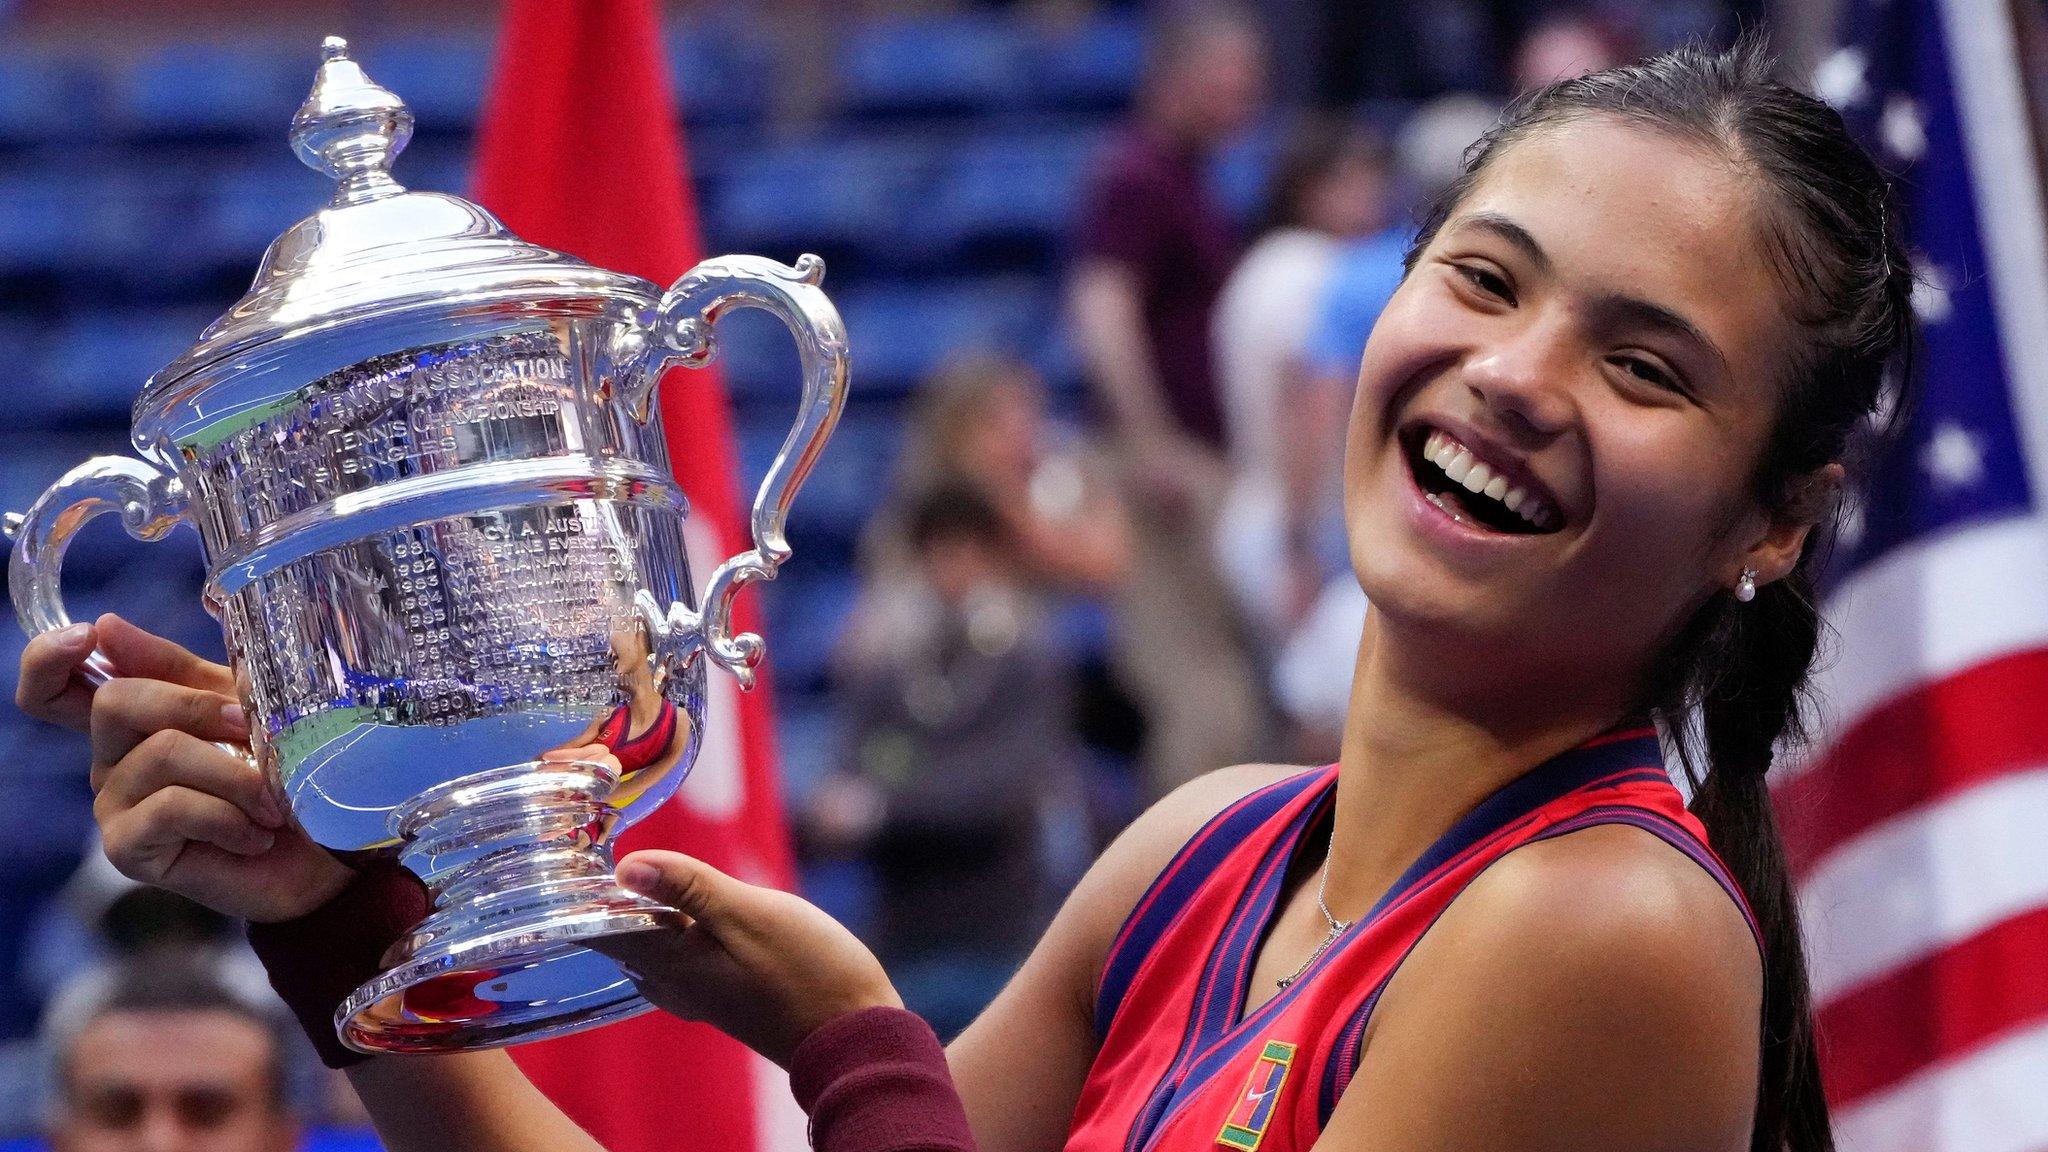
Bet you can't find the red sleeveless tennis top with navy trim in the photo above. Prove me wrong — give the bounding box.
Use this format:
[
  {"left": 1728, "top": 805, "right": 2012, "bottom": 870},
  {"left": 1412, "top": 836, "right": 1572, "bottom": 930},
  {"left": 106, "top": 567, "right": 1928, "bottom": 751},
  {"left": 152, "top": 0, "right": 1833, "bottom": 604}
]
[{"left": 1067, "top": 728, "right": 1761, "bottom": 1152}]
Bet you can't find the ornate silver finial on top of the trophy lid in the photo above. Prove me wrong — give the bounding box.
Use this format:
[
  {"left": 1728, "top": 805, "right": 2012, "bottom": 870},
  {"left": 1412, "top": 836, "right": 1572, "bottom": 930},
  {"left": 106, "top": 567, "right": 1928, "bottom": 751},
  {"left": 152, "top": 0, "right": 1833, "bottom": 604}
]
[{"left": 291, "top": 37, "right": 412, "bottom": 205}]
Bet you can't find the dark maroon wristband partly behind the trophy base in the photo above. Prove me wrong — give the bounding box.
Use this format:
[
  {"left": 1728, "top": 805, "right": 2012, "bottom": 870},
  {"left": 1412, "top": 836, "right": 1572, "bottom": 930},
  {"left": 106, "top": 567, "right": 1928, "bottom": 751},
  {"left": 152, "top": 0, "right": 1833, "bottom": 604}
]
[{"left": 250, "top": 861, "right": 432, "bottom": 1068}]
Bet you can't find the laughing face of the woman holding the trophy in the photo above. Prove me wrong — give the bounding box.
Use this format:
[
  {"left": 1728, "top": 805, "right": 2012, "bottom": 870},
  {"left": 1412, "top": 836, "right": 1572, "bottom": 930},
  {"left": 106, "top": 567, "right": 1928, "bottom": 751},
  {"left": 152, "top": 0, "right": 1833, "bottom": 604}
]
[{"left": 1346, "top": 119, "right": 1802, "bottom": 685}]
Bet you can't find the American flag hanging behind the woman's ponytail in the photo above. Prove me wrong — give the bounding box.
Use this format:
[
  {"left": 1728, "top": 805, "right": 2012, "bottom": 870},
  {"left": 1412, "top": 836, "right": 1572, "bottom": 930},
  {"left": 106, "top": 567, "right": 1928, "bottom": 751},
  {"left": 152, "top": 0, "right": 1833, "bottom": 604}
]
[{"left": 1774, "top": 0, "right": 2048, "bottom": 1152}]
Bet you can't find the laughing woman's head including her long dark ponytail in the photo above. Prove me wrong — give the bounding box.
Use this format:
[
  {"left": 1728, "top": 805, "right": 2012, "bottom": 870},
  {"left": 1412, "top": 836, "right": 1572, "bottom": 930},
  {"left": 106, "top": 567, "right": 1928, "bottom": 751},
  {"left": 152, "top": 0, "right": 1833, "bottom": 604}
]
[{"left": 1348, "top": 29, "right": 1913, "bottom": 1148}]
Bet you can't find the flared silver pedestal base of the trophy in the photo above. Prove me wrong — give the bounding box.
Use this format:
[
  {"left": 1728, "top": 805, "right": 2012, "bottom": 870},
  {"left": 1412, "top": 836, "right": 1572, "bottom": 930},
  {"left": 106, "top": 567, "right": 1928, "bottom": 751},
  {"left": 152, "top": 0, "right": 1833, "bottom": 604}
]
[{"left": 334, "top": 760, "right": 674, "bottom": 1054}]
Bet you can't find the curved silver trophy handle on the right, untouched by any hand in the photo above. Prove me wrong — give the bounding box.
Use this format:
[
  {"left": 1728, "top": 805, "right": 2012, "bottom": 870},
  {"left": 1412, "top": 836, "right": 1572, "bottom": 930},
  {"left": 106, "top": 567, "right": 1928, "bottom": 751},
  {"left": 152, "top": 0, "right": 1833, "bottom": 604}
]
[{"left": 629, "top": 254, "right": 848, "bottom": 689}]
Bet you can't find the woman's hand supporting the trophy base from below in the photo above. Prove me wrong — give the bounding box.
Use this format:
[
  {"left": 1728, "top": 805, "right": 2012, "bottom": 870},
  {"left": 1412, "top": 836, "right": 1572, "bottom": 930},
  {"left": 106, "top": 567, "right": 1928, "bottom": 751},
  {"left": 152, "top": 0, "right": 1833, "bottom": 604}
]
[{"left": 594, "top": 851, "right": 903, "bottom": 1068}]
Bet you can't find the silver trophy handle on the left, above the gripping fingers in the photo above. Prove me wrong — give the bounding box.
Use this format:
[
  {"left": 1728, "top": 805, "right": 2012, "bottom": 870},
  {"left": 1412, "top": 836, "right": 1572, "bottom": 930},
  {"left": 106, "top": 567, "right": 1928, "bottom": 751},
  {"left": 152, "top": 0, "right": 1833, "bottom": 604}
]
[{"left": 0, "top": 455, "right": 186, "bottom": 685}]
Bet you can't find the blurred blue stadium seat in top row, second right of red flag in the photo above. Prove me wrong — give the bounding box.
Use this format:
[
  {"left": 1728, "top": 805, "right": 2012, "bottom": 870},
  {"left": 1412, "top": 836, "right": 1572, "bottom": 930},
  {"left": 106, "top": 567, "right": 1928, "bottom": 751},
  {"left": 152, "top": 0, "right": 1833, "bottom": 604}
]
[{"left": 840, "top": 14, "right": 1026, "bottom": 117}]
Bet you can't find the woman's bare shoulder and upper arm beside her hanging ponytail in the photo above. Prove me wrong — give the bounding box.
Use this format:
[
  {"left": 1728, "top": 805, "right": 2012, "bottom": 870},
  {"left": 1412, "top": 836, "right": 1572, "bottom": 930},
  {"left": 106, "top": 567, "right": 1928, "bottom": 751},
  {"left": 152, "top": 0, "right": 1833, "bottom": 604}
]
[{"left": 1315, "top": 826, "right": 1763, "bottom": 1152}]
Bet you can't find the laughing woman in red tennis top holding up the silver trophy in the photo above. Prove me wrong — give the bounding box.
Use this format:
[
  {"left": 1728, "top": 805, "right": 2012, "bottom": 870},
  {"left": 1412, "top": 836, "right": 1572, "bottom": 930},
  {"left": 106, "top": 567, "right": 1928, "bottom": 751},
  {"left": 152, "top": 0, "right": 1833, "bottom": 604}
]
[{"left": 23, "top": 24, "right": 1911, "bottom": 1152}]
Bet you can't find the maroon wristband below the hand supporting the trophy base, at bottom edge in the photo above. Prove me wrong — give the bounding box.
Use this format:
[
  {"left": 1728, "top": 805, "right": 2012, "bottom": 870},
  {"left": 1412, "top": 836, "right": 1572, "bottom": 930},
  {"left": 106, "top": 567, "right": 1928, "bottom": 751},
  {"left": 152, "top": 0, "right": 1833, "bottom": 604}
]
[{"left": 788, "top": 1009, "right": 975, "bottom": 1152}]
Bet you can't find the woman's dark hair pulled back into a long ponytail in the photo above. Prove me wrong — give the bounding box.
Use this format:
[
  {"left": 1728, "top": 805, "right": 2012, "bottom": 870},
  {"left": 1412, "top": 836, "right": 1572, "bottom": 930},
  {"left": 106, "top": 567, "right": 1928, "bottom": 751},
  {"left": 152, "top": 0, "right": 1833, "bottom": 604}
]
[{"left": 1405, "top": 33, "right": 1913, "bottom": 1152}]
